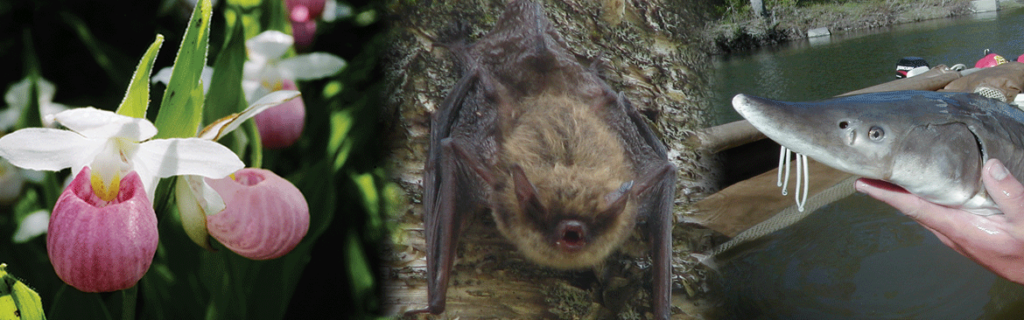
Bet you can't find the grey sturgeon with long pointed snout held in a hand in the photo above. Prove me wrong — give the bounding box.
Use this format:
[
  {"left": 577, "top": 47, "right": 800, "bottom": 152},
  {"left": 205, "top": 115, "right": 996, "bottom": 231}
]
[{"left": 732, "top": 91, "right": 1024, "bottom": 215}]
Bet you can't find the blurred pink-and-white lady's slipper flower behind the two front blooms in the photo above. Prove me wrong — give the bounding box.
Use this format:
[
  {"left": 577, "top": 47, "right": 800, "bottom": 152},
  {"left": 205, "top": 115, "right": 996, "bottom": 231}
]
[{"left": 242, "top": 30, "right": 345, "bottom": 149}]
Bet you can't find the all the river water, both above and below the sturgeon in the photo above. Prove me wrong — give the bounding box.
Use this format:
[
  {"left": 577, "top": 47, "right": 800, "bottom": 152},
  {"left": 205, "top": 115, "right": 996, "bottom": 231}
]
[{"left": 715, "top": 10, "right": 1024, "bottom": 319}]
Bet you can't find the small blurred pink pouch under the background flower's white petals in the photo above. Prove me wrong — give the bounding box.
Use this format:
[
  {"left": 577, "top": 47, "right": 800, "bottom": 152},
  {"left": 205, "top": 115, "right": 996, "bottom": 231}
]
[{"left": 255, "top": 79, "right": 306, "bottom": 149}]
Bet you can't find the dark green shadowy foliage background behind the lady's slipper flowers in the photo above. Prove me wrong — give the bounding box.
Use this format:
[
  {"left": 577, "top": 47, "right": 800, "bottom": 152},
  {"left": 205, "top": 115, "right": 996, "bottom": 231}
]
[{"left": 0, "top": 0, "right": 390, "bottom": 319}]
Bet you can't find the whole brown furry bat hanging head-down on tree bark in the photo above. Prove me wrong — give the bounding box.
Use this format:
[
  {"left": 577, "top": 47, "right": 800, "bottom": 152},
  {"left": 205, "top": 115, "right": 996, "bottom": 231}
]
[{"left": 407, "top": 0, "right": 676, "bottom": 319}]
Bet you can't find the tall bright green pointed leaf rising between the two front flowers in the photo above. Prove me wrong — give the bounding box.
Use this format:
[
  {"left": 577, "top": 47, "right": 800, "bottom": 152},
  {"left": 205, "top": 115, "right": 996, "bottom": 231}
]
[{"left": 156, "top": 0, "right": 212, "bottom": 138}]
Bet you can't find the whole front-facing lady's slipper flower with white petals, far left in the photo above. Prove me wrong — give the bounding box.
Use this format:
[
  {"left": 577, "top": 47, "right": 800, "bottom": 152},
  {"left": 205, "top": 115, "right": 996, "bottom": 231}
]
[{"left": 0, "top": 108, "right": 244, "bottom": 291}]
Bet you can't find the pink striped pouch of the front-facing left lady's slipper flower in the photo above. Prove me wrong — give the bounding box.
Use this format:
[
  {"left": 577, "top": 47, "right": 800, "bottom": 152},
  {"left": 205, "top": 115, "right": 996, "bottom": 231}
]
[{"left": 46, "top": 167, "right": 159, "bottom": 292}]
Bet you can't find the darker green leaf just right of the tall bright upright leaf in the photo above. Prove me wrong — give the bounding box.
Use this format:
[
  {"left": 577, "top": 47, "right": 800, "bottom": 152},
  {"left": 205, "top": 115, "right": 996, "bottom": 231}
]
[{"left": 203, "top": 16, "right": 246, "bottom": 123}]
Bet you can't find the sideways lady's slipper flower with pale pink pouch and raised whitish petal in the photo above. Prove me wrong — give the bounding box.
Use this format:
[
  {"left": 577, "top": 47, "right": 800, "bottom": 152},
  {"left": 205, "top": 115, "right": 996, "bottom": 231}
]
[{"left": 175, "top": 90, "right": 309, "bottom": 259}]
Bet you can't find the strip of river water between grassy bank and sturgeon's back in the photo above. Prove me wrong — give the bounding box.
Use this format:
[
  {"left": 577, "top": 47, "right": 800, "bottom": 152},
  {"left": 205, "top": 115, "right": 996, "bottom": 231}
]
[{"left": 712, "top": 9, "right": 1024, "bottom": 124}]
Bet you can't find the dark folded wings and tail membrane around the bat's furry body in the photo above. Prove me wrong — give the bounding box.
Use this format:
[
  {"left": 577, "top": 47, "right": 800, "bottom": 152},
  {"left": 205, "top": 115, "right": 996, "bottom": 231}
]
[{"left": 413, "top": 1, "right": 675, "bottom": 319}]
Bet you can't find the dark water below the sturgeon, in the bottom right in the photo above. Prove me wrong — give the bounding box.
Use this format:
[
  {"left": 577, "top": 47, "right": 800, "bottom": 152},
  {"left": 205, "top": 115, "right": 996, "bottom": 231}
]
[{"left": 720, "top": 194, "right": 1024, "bottom": 319}]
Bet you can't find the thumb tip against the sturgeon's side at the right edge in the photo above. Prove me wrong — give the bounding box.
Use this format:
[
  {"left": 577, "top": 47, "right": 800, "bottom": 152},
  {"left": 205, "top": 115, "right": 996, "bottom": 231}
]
[{"left": 982, "top": 159, "right": 1024, "bottom": 223}]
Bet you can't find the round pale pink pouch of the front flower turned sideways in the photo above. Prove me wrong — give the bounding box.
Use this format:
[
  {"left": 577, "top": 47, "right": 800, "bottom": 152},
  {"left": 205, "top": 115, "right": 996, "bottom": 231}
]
[{"left": 206, "top": 168, "right": 309, "bottom": 259}]
